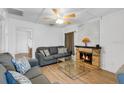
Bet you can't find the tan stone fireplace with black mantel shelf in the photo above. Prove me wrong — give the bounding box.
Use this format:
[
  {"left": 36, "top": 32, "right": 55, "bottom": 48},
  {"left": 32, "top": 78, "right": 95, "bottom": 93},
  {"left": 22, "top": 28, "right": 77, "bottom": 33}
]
[{"left": 75, "top": 46, "right": 101, "bottom": 68}]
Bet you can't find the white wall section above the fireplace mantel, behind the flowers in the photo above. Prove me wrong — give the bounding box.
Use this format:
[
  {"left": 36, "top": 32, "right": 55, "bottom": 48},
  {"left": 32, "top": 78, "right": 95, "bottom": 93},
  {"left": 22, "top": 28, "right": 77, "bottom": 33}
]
[{"left": 63, "top": 20, "right": 100, "bottom": 46}]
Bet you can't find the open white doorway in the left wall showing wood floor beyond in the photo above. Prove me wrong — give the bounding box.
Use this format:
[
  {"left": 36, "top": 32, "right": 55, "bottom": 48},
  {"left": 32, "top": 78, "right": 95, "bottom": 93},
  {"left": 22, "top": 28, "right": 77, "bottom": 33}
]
[{"left": 16, "top": 28, "right": 32, "bottom": 57}]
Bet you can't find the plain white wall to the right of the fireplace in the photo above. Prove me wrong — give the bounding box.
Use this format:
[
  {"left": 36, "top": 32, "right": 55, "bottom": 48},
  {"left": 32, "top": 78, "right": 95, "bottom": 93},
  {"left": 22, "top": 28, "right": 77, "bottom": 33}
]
[{"left": 100, "top": 12, "right": 124, "bottom": 72}]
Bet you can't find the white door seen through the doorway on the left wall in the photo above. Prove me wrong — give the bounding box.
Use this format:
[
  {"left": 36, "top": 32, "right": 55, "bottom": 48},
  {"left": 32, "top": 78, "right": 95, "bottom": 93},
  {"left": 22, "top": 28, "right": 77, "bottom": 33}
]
[{"left": 16, "top": 31, "right": 31, "bottom": 53}]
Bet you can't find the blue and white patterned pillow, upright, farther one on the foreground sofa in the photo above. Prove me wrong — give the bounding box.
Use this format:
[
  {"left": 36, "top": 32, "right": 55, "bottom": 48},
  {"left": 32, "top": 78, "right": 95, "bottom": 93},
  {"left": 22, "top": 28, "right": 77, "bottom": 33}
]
[{"left": 13, "top": 57, "right": 31, "bottom": 74}]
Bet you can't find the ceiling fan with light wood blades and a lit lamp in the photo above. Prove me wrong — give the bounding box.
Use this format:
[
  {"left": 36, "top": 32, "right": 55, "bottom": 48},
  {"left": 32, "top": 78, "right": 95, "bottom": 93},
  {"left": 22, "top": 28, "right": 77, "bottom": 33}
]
[{"left": 44, "top": 8, "right": 76, "bottom": 24}]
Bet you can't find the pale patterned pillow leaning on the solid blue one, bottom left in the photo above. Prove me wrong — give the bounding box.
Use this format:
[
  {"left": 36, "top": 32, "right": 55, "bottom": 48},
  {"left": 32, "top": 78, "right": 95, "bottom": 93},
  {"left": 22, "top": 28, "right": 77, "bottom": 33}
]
[{"left": 9, "top": 71, "right": 32, "bottom": 84}]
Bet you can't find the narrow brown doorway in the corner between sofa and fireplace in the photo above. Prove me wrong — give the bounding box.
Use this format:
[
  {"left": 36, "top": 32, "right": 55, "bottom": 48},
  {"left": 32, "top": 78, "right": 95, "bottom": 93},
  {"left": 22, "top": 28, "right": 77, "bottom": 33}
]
[{"left": 65, "top": 32, "right": 74, "bottom": 55}]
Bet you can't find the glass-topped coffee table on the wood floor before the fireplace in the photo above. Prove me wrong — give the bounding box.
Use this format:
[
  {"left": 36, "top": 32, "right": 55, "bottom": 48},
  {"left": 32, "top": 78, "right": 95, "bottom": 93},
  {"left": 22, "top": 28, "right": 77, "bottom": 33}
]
[{"left": 57, "top": 58, "right": 90, "bottom": 79}]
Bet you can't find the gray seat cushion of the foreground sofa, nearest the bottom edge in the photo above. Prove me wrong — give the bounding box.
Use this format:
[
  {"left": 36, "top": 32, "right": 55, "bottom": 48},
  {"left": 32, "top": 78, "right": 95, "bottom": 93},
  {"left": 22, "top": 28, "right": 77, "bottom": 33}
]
[{"left": 31, "top": 75, "right": 50, "bottom": 84}]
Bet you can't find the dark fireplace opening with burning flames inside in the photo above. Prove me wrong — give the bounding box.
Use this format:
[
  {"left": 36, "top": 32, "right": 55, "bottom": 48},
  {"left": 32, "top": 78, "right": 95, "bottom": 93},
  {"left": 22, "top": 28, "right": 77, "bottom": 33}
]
[{"left": 80, "top": 51, "right": 92, "bottom": 64}]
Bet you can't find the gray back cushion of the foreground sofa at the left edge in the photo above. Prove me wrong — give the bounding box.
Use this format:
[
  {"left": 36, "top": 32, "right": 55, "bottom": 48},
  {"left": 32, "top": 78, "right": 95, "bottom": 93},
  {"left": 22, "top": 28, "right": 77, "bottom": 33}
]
[{"left": 0, "top": 53, "right": 15, "bottom": 71}]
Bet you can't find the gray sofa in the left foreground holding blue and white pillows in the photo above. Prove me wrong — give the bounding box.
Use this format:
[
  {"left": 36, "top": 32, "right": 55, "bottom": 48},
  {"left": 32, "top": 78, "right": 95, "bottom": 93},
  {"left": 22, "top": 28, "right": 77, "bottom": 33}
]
[{"left": 0, "top": 53, "right": 50, "bottom": 84}]
